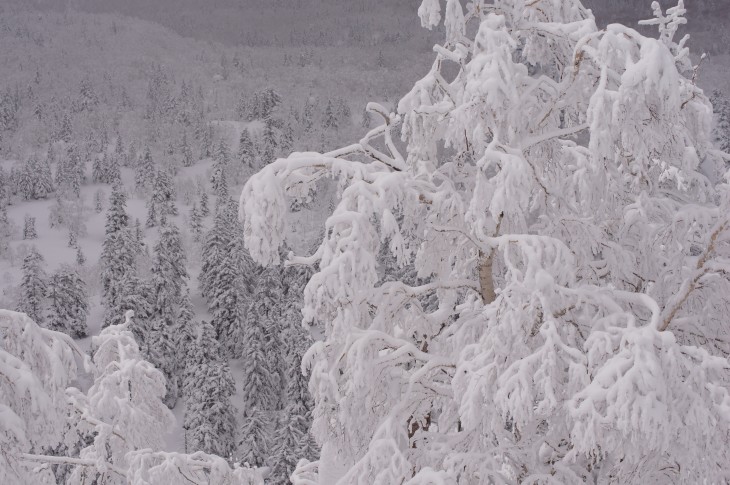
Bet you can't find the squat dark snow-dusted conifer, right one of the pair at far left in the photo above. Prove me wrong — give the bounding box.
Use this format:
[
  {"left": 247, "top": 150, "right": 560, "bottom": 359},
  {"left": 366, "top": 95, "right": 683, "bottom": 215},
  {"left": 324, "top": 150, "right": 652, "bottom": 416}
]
[{"left": 47, "top": 268, "right": 89, "bottom": 338}]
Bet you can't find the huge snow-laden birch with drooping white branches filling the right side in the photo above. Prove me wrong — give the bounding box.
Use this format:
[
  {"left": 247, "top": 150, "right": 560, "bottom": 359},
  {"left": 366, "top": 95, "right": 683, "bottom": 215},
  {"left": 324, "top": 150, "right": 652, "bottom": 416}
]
[{"left": 242, "top": 0, "right": 730, "bottom": 485}]
